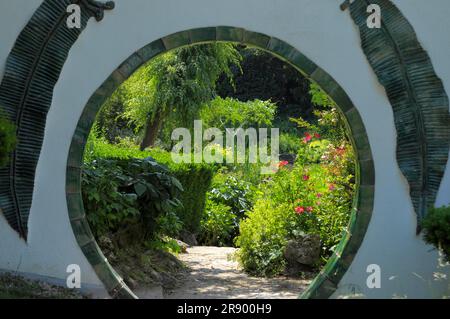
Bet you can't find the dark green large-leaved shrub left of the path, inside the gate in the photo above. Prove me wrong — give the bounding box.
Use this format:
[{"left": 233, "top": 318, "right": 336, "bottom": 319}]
[{"left": 82, "top": 158, "right": 183, "bottom": 240}]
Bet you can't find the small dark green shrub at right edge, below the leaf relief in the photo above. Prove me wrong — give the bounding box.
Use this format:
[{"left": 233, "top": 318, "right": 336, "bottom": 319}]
[{"left": 422, "top": 206, "right": 450, "bottom": 262}]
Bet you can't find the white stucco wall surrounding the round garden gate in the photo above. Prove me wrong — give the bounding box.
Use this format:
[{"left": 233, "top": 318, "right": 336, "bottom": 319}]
[{"left": 0, "top": 0, "right": 450, "bottom": 298}]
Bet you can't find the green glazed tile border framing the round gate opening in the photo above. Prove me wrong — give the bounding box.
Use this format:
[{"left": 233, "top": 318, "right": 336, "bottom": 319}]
[{"left": 66, "top": 26, "right": 375, "bottom": 298}]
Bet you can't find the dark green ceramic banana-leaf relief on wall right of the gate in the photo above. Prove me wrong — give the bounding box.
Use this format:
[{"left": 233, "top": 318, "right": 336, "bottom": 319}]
[{"left": 350, "top": 0, "right": 450, "bottom": 232}]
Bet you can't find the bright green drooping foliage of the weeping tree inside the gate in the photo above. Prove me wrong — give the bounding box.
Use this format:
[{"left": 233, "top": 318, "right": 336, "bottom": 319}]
[{"left": 99, "top": 43, "right": 241, "bottom": 147}]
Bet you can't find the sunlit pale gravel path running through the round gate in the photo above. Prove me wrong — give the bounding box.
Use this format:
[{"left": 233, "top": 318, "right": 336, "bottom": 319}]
[{"left": 159, "top": 247, "right": 311, "bottom": 299}]
